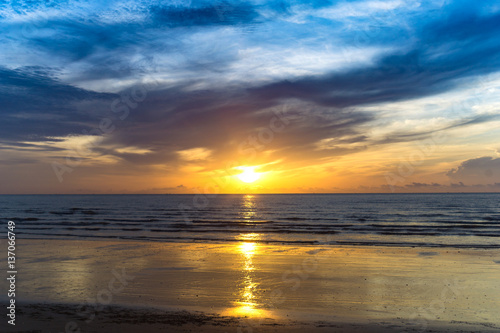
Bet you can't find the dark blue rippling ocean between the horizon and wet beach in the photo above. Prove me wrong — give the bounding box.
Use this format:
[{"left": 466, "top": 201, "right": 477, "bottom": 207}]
[{"left": 0, "top": 193, "right": 500, "bottom": 248}]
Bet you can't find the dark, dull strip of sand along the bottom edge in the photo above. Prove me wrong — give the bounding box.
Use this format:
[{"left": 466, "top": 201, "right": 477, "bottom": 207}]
[{"left": 6, "top": 303, "right": 499, "bottom": 333}]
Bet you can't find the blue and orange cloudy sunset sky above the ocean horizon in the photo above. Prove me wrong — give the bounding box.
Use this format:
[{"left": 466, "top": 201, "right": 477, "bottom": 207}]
[{"left": 0, "top": 0, "right": 500, "bottom": 194}]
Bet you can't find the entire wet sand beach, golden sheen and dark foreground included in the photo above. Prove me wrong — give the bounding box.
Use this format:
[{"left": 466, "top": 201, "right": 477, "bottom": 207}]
[{"left": 2, "top": 239, "right": 500, "bottom": 332}]
